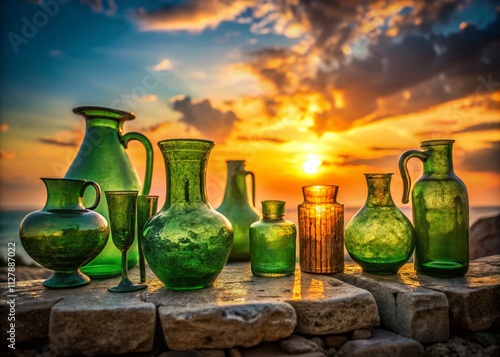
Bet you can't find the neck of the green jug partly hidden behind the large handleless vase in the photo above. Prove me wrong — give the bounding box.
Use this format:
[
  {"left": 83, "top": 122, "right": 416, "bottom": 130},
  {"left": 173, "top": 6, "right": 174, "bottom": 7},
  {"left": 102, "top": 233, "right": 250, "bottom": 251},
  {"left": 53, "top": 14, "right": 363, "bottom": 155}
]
[{"left": 222, "top": 160, "right": 249, "bottom": 205}]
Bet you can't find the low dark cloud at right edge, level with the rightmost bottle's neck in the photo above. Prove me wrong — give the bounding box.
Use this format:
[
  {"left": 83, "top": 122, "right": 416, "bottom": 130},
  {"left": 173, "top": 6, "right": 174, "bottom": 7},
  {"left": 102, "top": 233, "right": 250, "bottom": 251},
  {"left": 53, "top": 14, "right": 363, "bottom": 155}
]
[{"left": 460, "top": 141, "right": 500, "bottom": 173}]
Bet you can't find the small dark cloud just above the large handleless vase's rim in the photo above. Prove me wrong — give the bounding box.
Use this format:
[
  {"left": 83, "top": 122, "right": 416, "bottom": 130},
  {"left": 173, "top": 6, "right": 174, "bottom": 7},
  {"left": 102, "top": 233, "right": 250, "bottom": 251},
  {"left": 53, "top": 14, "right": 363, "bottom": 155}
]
[{"left": 173, "top": 97, "right": 240, "bottom": 143}]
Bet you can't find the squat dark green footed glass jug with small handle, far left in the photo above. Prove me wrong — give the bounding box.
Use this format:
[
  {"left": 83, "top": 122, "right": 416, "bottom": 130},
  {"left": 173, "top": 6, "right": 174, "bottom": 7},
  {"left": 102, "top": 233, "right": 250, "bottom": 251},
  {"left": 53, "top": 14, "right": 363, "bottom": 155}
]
[{"left": 19, "top": 178, "right": 109, "bottom": 289}]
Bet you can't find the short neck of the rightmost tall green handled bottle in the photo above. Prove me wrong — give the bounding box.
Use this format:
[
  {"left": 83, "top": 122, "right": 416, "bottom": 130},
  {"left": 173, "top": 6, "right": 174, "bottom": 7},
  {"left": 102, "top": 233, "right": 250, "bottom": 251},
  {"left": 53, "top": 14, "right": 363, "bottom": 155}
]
[{"left": 422, "top": 140, "right": 453, "bottom": 175}]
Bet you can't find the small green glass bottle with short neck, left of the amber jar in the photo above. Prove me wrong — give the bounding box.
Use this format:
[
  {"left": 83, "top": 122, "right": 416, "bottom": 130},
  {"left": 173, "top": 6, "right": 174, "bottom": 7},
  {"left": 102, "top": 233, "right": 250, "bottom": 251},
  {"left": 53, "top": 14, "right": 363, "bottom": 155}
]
[{"left": 250, "top": 200, "right": 297, "bottom": 277}]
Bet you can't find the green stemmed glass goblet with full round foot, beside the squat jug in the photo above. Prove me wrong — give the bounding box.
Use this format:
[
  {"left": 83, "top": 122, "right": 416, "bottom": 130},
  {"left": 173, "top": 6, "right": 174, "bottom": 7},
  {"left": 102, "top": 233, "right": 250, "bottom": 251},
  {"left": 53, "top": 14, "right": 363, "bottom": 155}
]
[{"left": 105, "top": 191, "right": 147, "bottom": 293}]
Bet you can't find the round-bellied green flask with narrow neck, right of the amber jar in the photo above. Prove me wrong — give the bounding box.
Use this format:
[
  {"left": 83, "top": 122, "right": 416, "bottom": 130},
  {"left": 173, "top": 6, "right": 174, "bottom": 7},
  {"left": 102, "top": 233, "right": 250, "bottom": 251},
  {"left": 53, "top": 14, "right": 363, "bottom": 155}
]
[{"left": 345, "top": 173, "right": 415, "bottom": 274}]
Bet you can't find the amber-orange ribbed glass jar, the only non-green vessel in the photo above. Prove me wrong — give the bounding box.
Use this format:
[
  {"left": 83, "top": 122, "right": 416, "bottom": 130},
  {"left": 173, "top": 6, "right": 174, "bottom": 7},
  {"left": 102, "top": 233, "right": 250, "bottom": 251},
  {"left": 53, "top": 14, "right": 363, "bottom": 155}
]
[{"left": 298, "top": 185, "right": 344, "bottom": 274}]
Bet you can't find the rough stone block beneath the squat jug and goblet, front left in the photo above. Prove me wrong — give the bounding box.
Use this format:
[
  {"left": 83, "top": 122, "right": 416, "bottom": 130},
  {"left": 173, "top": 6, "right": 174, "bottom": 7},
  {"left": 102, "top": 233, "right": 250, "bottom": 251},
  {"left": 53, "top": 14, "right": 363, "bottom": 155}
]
[{"left": 49, "top": 280, "right": 156, "bottom": 356}]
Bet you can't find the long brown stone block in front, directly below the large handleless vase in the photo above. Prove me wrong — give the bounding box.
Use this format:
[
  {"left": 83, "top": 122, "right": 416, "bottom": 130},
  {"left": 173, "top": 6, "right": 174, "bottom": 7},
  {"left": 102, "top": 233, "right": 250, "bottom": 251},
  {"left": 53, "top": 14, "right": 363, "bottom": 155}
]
[{"left": 158, "top": 302, "right": 297, "bottom": 350}]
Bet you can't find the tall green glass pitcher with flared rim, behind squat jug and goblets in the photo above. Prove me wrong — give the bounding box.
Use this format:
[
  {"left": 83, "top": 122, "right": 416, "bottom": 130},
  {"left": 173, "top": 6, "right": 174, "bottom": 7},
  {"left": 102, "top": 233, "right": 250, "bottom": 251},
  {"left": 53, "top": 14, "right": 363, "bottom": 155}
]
[{"left": 65, "top": 106, "right": 153, "bottom": 278}]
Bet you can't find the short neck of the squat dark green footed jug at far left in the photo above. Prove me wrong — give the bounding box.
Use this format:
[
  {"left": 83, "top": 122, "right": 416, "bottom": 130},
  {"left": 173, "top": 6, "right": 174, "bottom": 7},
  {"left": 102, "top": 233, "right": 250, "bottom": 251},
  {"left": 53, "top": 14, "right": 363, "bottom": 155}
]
[{"left": 42, "top": 178, "right": 85, "bottom": 211}]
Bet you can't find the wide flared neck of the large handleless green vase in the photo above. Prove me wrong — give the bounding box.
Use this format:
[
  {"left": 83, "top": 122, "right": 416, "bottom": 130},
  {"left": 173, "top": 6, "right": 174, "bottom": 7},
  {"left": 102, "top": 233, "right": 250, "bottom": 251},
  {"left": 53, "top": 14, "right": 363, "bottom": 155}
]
[{"left": 158, "top": 139, "right": 214, "bottom": 208}]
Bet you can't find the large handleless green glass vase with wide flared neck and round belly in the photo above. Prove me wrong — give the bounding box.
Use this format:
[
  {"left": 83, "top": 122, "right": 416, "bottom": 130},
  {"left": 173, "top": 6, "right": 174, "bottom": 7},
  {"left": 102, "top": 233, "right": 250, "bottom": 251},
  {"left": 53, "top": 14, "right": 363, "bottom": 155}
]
[{"left": 143, "top": 139, "right": 233, "bottom": 290}]
